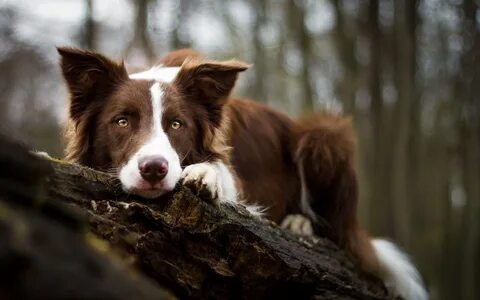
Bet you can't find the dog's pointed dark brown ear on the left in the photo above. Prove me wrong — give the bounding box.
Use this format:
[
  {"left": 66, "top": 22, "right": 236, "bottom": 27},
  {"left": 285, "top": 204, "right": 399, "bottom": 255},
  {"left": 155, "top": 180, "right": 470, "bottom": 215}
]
[{"left": 57, "top": 48, "right": 128, "bottom": 120}]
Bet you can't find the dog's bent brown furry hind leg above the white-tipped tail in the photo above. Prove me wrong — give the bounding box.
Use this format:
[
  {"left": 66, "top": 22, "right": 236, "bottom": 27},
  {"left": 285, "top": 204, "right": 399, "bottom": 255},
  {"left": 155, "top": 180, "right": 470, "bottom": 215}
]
[{"left": 294, "top": 115, "right": 358, "bottom": 248}]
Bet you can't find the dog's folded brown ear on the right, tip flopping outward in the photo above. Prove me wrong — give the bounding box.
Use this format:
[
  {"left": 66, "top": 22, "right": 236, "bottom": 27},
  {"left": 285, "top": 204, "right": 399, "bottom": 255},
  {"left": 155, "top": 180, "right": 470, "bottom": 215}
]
[{"left": 174, "top": 57, "right": 249, "bottom": 105}]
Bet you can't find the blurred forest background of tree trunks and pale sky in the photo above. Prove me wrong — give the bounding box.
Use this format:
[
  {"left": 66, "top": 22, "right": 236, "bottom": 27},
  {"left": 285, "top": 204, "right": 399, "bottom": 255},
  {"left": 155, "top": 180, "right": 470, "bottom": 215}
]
[{"left": 0, "top": 0, "right": 480, "bottom": 299}]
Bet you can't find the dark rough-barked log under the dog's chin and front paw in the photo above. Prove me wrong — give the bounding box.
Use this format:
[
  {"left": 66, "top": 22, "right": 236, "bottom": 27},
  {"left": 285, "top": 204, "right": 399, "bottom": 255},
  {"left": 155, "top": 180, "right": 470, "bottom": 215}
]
[{"left": 0, "top": 137, "right": 389, "bottom": 299}]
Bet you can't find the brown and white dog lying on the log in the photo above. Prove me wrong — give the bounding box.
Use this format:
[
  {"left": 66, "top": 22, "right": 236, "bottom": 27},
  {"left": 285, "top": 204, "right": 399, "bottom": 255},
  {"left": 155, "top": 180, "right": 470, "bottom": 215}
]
[{"left": 58, "top": 48, "right": 427, "bottom": 299}]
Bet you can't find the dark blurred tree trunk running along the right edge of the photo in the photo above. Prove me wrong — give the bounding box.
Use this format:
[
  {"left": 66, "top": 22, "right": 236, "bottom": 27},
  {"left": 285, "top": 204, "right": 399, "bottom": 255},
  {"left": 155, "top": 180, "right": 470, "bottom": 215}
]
[{"left": 458, "top": 0, "right": 480, "bottom": 299}]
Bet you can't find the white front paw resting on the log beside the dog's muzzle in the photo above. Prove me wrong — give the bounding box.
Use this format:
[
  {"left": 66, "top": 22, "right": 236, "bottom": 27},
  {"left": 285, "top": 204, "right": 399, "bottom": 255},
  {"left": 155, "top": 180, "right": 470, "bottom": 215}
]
[{"left": 182, "top": 162, "right": 237, "bottom": 203}]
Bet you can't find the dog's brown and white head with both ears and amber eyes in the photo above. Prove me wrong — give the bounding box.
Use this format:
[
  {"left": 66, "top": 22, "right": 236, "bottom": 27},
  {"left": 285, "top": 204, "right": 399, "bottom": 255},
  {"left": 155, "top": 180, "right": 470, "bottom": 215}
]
[{"left": 59, "top": 48, "right": 247, "bottom": 198}]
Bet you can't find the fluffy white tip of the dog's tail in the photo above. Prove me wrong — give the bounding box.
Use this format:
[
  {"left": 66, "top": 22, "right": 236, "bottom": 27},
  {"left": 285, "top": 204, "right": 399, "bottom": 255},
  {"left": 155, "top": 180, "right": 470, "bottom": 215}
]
[{"left": 372, "top": 239, "right": 428, "bottom": 300}]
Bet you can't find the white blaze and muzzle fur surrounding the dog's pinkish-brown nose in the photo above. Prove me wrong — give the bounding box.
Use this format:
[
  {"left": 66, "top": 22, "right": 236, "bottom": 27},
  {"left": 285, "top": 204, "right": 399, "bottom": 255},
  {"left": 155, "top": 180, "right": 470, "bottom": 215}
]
[{"left": 119, "top": 82, "right": 182, "bottom": 198}]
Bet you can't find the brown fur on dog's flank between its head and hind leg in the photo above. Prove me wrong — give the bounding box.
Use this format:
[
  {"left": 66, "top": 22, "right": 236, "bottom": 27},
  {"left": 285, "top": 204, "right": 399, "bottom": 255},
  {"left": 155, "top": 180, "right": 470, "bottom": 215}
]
[{"left": 225, "top": 99, "right": 300, "bottom": 222}]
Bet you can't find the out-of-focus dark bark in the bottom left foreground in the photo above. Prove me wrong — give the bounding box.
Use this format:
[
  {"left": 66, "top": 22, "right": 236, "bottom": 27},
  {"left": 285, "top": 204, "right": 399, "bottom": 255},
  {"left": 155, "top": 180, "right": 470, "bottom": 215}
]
[{"left": 0, "top": 140, "right": 172, "bottom": 300}]
